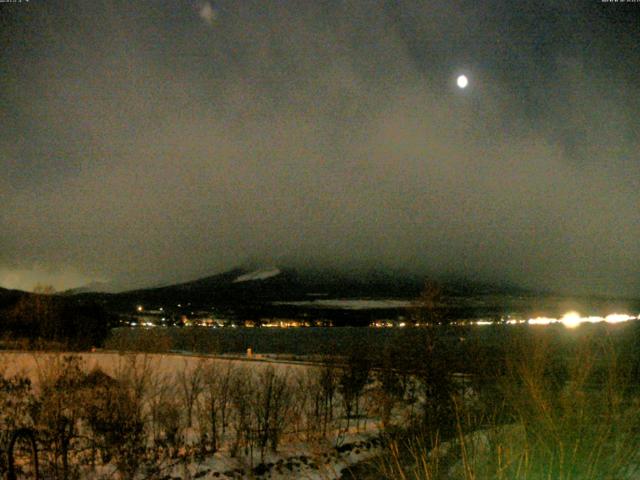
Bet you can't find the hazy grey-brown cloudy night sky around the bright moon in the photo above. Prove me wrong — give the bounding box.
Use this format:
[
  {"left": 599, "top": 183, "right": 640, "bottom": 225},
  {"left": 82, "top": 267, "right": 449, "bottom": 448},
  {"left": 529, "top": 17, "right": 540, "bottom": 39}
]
[{"left": 0, "top": 0, "right": 640, "bottom": 295}]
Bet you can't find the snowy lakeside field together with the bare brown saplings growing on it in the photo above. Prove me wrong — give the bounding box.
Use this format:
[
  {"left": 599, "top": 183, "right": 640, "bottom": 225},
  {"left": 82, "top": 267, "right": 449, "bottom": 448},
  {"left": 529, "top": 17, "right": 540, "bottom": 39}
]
[{"left": 0, "top": 352, "right": 390, "bottom": 480}]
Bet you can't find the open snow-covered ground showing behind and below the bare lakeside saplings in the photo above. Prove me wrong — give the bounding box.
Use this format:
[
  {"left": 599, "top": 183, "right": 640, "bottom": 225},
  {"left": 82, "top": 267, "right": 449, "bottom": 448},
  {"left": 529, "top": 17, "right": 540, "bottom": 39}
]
[{"left": 0, "top": 352, "right": 380, "bottom": 480}]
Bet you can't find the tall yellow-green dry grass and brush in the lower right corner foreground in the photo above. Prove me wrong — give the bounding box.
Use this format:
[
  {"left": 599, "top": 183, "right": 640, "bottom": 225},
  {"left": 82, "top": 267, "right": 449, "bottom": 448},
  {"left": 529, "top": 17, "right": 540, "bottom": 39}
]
[{"left": 378, "top": 327, "right": 640, "bottom": 480}]
